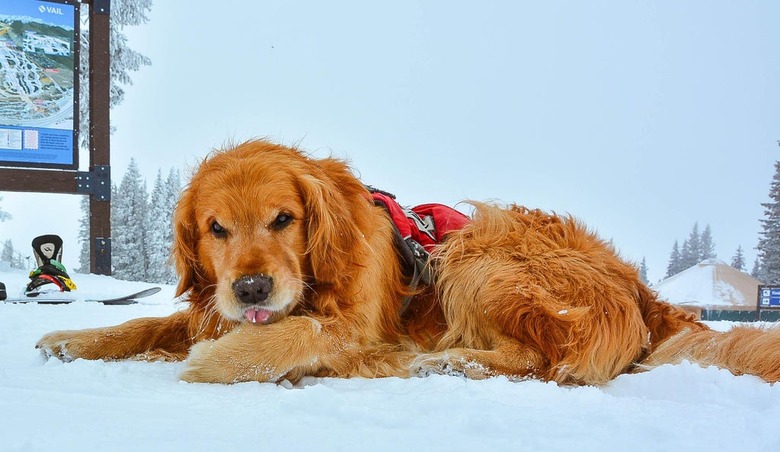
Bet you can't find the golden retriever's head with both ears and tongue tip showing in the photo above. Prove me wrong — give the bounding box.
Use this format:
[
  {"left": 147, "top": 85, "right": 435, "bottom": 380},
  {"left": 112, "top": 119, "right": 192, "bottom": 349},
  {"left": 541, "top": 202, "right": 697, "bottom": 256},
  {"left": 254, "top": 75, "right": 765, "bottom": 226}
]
[{"left": 173, "top": 141, "right": 369, "bottom": 323}]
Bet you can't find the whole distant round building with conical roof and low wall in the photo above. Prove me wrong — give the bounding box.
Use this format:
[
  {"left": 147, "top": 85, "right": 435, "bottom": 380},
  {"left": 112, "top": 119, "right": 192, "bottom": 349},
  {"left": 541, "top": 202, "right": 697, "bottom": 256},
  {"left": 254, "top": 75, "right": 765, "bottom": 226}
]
[{"left": 652, "top": 259, "right": 780, "bottom": 321}]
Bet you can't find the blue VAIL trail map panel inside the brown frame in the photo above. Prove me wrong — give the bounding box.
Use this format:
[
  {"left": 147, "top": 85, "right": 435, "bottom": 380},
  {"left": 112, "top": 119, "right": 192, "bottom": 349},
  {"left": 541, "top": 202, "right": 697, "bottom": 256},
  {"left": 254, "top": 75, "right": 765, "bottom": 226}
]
[{"left": 0, "top": 0, "right": 79, "bottom": 169}]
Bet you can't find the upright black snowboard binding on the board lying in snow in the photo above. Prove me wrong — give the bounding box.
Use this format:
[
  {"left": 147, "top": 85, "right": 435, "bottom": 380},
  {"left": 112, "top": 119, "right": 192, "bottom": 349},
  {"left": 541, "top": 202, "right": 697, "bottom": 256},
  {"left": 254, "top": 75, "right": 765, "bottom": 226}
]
[{"left": 25, "top": 234, "right": 76, "bottom": 297}]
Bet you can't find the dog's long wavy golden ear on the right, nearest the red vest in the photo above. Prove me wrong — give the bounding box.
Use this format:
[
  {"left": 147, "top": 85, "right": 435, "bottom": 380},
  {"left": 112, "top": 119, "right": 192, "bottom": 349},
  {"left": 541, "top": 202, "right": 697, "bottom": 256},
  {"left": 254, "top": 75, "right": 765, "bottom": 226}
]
[{"left": 299, "top": 159, "right": 370, "bottom": 287}]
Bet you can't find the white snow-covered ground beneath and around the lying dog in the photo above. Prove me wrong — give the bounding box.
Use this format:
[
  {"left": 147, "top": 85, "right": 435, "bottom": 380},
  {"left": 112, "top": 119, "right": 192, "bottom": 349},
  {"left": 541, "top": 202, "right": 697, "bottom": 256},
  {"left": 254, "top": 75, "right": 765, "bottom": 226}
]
[{"left": 0, "top": 271, "right": 780, "bottom": 452}]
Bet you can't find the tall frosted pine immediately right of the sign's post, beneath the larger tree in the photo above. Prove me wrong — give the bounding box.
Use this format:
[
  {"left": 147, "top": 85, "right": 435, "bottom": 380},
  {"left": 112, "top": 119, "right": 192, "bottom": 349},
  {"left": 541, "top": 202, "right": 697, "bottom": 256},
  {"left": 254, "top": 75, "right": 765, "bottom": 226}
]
[{"left": 111, "top": 159, "right": 149, "bottom": 281}]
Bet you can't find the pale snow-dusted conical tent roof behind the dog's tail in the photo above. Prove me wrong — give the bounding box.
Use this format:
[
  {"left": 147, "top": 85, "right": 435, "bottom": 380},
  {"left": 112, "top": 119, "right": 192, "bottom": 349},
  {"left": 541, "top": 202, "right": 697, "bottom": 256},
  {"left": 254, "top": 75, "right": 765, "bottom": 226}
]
[{"left": 653, "top": 259, "right": 761, "bottom": 310}]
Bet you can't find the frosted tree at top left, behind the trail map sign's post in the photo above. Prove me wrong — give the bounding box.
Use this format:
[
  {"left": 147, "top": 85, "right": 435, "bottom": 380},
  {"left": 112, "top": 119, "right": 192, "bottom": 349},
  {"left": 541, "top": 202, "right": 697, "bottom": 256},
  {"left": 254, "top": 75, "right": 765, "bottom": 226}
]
[{"left": 79, "top": 0, "right": 152, "bottom": 149}]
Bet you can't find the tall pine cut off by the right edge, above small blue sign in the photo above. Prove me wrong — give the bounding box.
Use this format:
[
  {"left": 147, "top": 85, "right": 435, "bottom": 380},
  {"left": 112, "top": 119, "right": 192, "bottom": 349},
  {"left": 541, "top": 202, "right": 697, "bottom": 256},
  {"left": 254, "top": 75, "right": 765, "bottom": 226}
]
[{"left": 756, "top": 161, "right": 780, "bottom": 284}]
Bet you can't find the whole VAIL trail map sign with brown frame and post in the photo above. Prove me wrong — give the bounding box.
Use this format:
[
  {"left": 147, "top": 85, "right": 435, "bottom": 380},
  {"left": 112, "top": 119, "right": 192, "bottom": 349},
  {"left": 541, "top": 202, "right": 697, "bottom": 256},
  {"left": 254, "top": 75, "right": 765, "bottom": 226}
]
[{"left": 0, "top": 0, "right": 111, "bottom": 275}]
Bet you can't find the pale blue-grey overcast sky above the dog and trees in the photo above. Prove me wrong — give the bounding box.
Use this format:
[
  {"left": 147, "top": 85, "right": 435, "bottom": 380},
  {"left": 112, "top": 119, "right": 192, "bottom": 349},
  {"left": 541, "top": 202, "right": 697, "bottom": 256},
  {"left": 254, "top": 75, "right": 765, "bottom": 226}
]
[{"left": 0, "top": 0, "right": 780, "bottom": 282}]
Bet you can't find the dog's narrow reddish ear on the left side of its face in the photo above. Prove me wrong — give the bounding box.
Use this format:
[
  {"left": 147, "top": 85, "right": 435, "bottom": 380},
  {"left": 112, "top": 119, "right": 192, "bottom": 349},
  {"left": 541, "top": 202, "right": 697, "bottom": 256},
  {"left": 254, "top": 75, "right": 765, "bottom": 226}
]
[{"left": 172, "top": 188, "right": 198, "bottom": 297}]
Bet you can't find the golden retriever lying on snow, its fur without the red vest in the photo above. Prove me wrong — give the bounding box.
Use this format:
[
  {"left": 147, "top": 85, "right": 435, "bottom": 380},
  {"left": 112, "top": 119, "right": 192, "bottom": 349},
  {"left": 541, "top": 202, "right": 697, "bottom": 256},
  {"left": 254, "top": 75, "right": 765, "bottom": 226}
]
[{"left": 37, "top": 140, "right": 780, "bottom": 385}]
